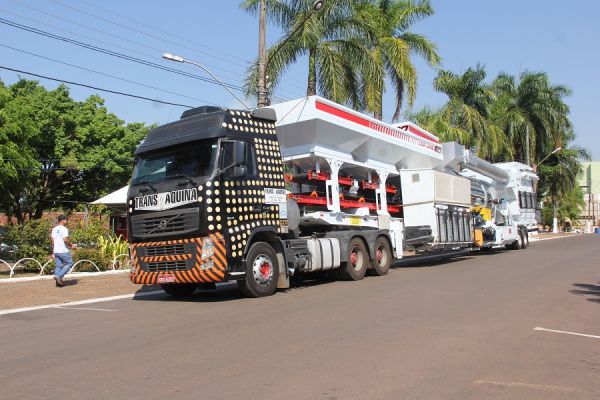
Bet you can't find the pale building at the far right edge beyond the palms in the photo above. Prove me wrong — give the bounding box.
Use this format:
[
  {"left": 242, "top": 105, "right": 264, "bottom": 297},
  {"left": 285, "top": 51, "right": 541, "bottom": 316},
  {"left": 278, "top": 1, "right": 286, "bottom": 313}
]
[{"left": 579, "top": 161, "right": 600, "bottom": 232}]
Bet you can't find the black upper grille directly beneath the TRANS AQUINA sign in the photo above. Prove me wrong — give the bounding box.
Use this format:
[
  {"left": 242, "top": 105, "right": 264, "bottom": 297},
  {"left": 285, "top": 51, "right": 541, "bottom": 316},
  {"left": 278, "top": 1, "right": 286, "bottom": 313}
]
[{"left": 131, "top": 207, "right": 200, "bottom": 239}]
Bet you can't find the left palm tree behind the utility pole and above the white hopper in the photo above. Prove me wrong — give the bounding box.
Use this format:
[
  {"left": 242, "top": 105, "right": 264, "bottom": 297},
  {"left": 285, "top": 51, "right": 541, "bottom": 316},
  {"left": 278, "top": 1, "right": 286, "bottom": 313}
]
[{"left": 241, "top": 0, "right": 369, "bottom": 108}]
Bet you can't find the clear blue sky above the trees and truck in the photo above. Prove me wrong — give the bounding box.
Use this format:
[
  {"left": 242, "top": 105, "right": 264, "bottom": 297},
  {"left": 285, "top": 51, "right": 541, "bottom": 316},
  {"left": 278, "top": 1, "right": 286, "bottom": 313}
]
[{"left": 0, "top": 0, "right": 600, "bottom": 160}]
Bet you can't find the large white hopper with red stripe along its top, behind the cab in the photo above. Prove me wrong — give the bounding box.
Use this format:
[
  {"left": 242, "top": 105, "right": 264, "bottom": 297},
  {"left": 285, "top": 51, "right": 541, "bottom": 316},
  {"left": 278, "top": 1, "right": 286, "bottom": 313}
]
[{"left": 271, "top": 96, "right": 443, "bottom": 169}]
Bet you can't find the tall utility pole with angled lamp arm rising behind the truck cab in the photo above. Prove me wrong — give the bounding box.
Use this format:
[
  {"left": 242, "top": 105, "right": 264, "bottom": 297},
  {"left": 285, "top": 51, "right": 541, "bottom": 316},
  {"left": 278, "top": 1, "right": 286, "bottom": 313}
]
[{"left": 256, "top": 0, "right": 323, "bottom": 108}]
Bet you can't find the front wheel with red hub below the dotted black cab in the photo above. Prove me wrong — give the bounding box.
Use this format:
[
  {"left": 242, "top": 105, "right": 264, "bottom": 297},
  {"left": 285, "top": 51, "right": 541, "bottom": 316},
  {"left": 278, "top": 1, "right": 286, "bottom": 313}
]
[{"left": 237, "top": 242, "right": 279, "bottom": 297}]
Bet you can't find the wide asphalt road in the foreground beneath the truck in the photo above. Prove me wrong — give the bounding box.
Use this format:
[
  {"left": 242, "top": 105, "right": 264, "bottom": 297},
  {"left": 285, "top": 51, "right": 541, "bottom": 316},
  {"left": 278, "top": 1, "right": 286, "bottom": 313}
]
[{"left": 0, "top": 236, "right": 600, "bottom": 400}]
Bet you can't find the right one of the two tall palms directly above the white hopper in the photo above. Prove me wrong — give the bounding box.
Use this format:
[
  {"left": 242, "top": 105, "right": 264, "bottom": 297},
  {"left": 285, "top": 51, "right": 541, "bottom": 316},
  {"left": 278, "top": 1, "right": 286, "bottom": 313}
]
[{"left": 353, "top": 0, "right": 440, "bottom": 120}]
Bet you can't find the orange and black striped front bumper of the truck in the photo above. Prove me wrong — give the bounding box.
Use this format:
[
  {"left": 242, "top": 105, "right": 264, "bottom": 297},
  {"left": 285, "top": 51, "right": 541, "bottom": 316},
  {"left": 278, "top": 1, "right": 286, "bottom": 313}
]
[{"left": 129, "top": 233, "right": 227, "bottom": 285}]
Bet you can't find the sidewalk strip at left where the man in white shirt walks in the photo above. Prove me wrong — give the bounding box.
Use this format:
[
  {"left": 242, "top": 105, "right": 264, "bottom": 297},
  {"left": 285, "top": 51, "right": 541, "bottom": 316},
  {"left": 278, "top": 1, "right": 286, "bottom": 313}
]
[{"left": 0, "top": 274, "right": 160, "bottom": 310}]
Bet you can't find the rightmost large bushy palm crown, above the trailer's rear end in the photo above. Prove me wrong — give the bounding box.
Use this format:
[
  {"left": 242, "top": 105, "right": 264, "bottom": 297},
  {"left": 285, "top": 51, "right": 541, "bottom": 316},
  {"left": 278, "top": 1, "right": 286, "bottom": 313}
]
[{"left": 490, "top": 71, "right": 571, "bottom": 164}]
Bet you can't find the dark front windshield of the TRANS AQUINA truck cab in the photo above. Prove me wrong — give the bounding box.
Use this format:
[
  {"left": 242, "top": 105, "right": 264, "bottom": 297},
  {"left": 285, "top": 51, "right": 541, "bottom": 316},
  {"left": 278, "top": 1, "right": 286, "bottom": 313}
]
[{"left": 131, "top": 140, "right": 218, "bottom": 185}]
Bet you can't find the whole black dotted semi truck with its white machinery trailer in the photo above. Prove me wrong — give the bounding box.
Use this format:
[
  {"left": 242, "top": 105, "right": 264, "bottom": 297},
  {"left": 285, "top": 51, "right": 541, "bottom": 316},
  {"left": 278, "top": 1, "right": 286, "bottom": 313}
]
[{"left": 127, "top": 96, "right": 536, "bottom": 297}]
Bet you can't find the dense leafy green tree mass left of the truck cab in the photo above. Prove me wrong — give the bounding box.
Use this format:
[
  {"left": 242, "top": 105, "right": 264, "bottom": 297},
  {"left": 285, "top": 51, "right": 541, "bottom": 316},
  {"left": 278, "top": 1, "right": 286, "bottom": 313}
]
[{"left": 0, "top": 79, "right": 148, "bottom": 222}]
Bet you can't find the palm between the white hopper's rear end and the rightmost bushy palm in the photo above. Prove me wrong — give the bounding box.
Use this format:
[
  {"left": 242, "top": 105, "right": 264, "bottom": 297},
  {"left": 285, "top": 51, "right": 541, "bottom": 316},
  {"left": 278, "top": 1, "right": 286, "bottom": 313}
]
[{"left": 433, "top": 64, "right": 512, "bottom": 160}]
